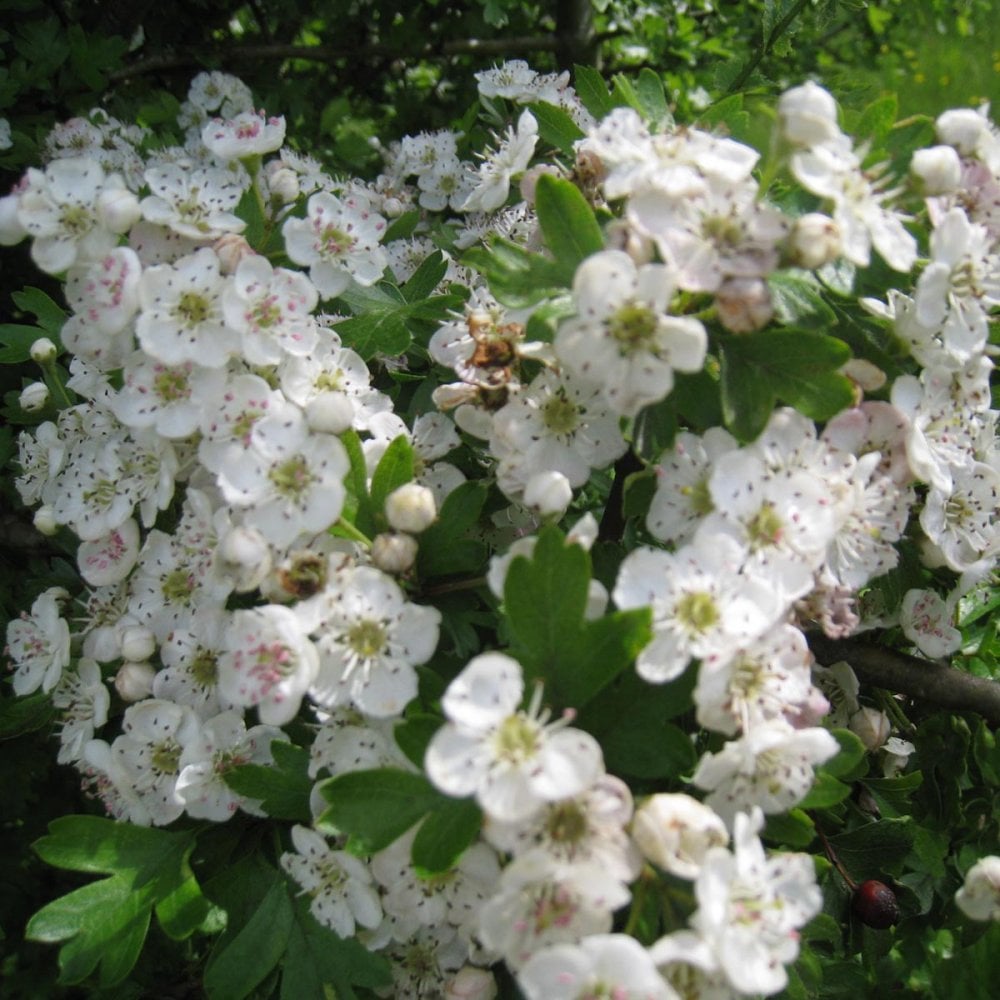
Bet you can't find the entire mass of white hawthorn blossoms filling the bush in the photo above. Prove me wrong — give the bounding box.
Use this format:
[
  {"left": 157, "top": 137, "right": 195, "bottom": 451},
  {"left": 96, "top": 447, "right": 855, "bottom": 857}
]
[{"left": 0, "top": 63, "right": 1000, "bottom": 1000}]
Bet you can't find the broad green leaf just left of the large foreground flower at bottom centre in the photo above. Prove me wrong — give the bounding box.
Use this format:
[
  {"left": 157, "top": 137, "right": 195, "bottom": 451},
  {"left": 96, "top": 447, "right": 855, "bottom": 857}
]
[{"left": 320, "top": 767, "right": 445, "bottom": 854}]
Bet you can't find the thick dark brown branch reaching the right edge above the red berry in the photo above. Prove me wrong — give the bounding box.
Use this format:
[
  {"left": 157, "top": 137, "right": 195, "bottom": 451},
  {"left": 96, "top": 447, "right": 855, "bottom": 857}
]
[{"left": 809, "top": 635, "right": 1000, "bottom": 726}]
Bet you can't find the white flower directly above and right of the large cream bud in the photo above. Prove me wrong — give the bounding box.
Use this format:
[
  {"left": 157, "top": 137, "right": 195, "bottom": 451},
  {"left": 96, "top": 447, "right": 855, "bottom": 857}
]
[{"left": 691, "top": 719, "right": 840, "bottom": 823}]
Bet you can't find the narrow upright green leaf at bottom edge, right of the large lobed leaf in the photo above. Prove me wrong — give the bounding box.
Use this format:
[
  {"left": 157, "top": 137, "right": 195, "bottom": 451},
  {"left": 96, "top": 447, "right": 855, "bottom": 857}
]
[{"left": 204, "top": 869, "right": 292, "bottom": 1000}]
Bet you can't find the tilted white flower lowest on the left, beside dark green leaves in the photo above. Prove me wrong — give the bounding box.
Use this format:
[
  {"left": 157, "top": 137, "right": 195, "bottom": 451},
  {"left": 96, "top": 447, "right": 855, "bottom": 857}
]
[{"left": 281, "top": 826, "right": 382, "bottom": 939}]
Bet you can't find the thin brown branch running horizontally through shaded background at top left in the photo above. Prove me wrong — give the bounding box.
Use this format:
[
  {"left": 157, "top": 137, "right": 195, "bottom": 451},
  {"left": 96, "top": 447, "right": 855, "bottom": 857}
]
[{"left": 111, "top": 34, "right": 563, "bottom": 83}]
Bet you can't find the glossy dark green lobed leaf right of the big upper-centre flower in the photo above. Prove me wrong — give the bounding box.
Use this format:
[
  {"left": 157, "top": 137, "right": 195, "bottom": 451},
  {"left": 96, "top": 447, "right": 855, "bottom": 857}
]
[{"left": 719, "top": 329, "right": 854, "bottom": 441}]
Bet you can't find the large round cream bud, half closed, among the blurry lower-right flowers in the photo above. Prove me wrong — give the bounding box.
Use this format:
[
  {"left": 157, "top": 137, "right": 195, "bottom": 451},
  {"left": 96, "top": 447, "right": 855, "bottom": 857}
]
[{"left": 632, "top": 794, "right": 729, "bottom": 879}]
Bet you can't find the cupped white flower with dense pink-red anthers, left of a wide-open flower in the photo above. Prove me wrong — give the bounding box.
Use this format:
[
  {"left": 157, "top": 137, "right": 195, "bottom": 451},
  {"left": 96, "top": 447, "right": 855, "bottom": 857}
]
[{"left": 219, "top": 604, "right": 319, "bottom": 726}]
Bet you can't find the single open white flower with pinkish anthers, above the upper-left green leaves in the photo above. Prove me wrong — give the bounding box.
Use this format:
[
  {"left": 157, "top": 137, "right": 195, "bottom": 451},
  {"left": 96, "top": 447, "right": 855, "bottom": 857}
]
[{"left": 281, "top": 192, "right": 387, "bottom": 299}]
